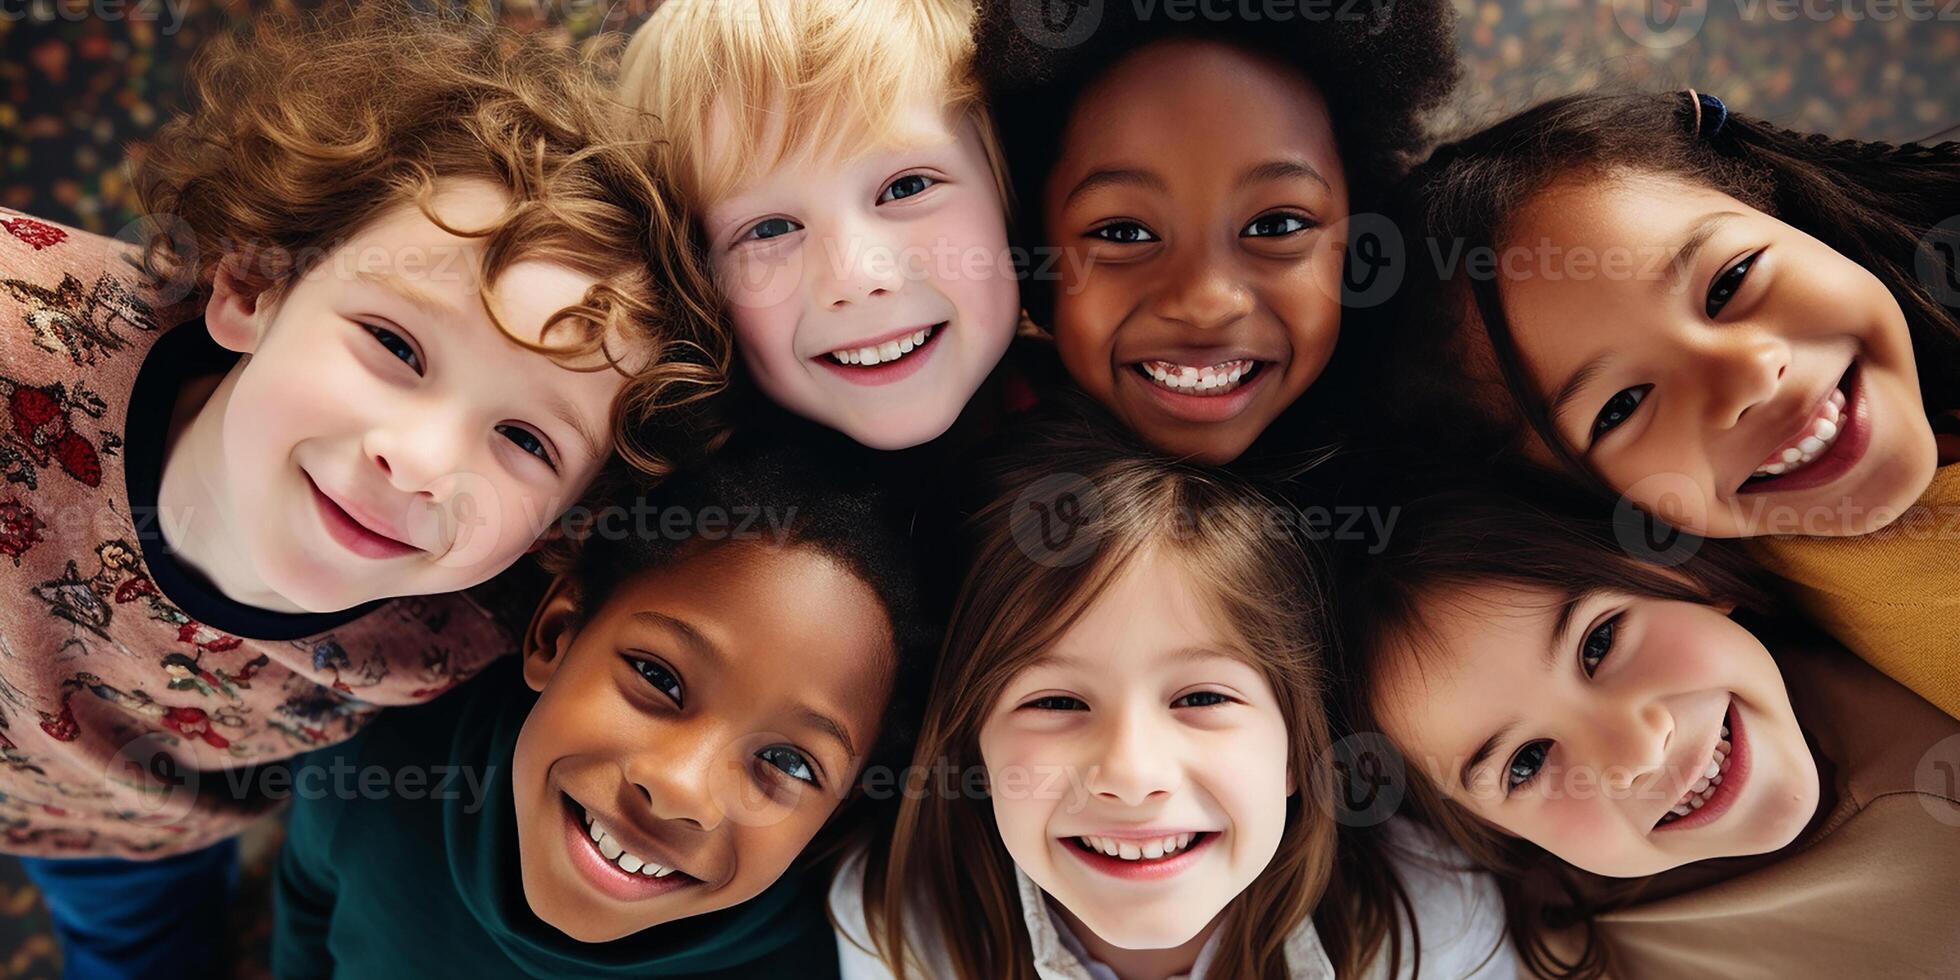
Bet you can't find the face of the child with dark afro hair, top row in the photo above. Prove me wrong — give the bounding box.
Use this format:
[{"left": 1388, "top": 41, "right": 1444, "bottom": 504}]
[{"left": 1041, "top": 41, "right": 1348, "bottom": 463}]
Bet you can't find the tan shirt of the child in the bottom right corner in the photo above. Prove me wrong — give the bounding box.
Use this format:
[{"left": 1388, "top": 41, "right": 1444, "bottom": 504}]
[{"left": 1552, "top": 649, "right": 1960, "bottom": 980}]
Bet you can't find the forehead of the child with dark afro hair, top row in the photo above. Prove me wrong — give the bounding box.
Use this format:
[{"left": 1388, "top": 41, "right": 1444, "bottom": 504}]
[{"left": 1056, "top": 41, "right": 1343, "bottom": 188}]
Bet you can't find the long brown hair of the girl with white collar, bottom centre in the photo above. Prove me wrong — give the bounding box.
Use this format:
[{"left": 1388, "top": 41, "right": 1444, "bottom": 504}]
[{"left": 864, "top": 406, "right": 1380, "bottom": 980}]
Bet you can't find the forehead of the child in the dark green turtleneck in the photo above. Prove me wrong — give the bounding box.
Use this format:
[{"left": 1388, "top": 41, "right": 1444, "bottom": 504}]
[{"left": 596, "top": 544, "right": 894, "bottom": 729}]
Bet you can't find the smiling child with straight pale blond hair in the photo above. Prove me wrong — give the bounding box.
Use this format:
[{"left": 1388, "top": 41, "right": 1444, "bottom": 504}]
[{"left": 619, "top": 0, "right": 1021, "bottom": 449}]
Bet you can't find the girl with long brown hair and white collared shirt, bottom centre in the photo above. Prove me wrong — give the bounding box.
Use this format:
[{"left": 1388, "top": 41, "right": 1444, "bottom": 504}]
[{"left": 831, "top": 399, "right": 1511, "bottom": 980}]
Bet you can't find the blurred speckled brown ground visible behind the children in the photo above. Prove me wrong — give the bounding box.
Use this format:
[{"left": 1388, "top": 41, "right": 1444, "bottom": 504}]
[{"left": 0, "top": 0, "right": 1960, "bottom": 978}]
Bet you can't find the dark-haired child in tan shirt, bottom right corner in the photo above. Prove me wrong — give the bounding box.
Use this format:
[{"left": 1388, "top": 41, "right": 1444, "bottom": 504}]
[{"left": 1335, "top": 474, "right": 1960, "bottom": 978}]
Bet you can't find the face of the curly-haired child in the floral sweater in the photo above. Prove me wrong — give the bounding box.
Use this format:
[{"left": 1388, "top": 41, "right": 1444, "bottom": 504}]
[{"left": 206, "top": 182, "right": 625, "bottom": 612}]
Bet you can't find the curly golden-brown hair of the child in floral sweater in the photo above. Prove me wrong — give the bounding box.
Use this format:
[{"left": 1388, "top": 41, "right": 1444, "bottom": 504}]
[{"left": 131, "top": 4, "right": 731, "bottom": 478}]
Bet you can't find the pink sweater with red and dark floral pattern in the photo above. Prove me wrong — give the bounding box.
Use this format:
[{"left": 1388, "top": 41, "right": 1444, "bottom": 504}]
[{"left": 0, "top": 210, "right": 515, "bottom": 858}]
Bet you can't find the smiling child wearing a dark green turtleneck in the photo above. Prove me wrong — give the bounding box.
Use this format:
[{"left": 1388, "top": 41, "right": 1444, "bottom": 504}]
[{"left": 274, "top": 433, "right": 937, "bottom": 978}]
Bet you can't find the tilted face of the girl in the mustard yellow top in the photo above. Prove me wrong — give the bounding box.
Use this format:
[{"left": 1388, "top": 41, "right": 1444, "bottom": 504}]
[{"left": 1503, "top": 176, "right": 1938, "bottom": 537}]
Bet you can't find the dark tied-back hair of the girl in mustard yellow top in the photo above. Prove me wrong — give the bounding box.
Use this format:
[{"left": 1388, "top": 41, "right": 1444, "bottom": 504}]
[{"left": 1343, "top": 92, "right": 1960, "bottom": 482}]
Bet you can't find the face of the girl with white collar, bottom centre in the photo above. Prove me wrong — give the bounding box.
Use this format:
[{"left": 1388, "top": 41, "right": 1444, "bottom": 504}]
[{"left": 980, "top": 549, "right": 1294, "bottom": 949}]
